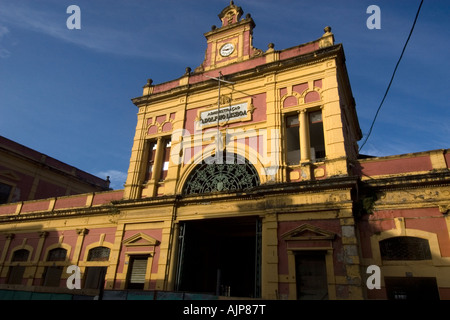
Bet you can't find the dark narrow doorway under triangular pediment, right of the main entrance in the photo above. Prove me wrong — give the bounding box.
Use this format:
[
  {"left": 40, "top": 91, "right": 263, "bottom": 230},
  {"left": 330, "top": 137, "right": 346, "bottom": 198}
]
[{"left": 295, "top": 251, "right": 328, "bottom": 300}]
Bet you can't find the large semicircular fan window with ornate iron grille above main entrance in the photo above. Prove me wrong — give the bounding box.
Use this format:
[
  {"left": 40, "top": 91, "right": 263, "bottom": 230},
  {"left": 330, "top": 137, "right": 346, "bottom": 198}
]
[{"left": 183, "top": 152, "right": 260, "bottom": 195}]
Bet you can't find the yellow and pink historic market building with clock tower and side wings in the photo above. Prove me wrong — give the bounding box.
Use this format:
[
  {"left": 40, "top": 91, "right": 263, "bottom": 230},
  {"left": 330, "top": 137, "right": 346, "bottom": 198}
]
[{"left": 0, "top": 2, "right": 450, "bottom": 299}]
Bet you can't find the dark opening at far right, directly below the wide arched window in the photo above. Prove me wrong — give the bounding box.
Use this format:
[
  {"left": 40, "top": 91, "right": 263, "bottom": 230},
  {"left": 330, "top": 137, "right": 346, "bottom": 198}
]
[{"left": 384, "top": 277, "right": 439, "bottom": 300}]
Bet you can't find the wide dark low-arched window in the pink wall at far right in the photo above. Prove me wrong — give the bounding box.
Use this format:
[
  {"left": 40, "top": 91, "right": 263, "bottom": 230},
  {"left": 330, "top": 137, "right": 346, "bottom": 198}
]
[{"left": 380, "top": 237, "right": 431, "bottom": 260}]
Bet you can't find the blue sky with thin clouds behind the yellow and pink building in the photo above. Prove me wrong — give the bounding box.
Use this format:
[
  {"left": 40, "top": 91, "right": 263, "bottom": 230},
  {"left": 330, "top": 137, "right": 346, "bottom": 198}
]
[{"left": 0, "top": 0, "right": 450, "bottom": 189}]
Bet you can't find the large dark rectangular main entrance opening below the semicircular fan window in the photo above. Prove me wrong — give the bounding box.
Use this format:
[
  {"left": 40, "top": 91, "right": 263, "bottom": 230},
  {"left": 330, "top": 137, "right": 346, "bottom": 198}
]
[{"left": 177, "top": 217, "right": 260, "bottom": 297}]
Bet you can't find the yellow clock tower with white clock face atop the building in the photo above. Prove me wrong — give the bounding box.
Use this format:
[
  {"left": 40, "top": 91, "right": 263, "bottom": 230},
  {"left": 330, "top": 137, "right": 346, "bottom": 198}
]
[{"left": 195, "top": 1, "right": 263, "bottom": 72}]
